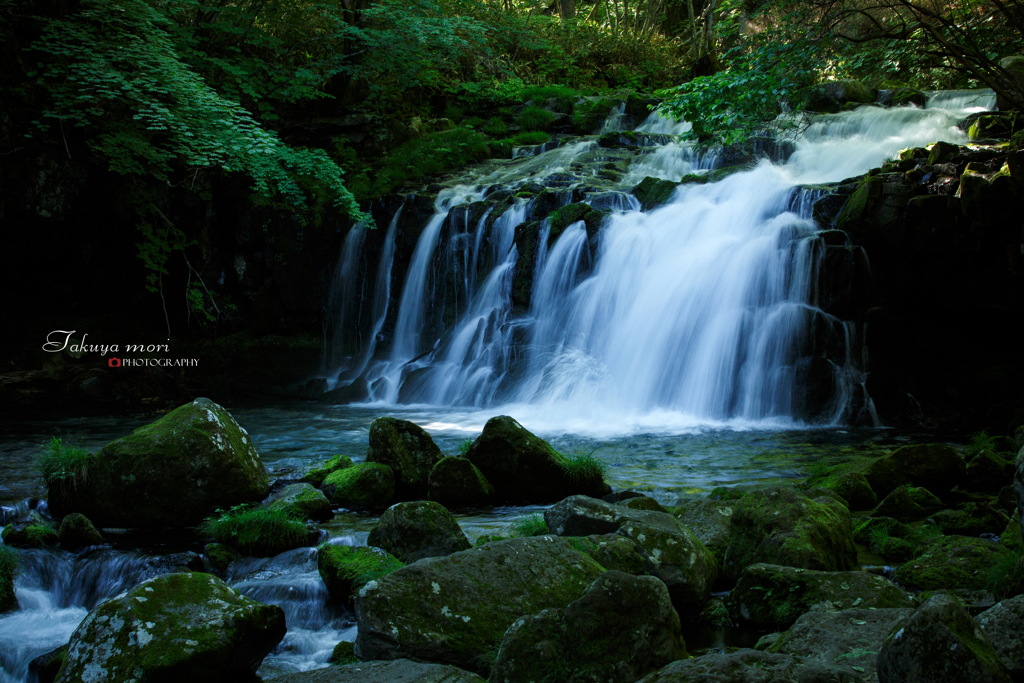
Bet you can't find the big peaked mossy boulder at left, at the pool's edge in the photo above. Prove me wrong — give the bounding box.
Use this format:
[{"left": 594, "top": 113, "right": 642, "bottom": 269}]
[{"left": 47, "top": 398, "right": 268, "bottom": 527}]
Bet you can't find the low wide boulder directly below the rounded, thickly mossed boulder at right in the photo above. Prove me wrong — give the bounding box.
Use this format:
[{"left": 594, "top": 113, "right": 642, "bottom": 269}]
[{"left": 726, "top": 563, "right": 913, "bottom": 629}]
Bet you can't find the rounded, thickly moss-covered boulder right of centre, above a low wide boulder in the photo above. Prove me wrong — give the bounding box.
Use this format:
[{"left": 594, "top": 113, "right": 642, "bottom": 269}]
[{"left": 724, "top": 486, "right": 857, "bottom": 578}]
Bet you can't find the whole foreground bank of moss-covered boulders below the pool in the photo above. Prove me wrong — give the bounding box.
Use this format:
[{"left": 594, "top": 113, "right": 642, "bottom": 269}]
[{"left": 0, "top": 399, "right": 1024, "bottom": 683}]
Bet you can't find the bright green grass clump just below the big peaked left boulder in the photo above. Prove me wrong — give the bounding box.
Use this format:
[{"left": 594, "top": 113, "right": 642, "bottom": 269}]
[{"left": 197, "top": 505, "right": 308, "bottom": 557}]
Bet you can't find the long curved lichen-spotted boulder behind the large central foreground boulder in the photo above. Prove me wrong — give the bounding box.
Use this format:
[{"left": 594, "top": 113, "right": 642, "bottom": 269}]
[{"left": 544, "top": 496, "right": 718, "bottom": 618}]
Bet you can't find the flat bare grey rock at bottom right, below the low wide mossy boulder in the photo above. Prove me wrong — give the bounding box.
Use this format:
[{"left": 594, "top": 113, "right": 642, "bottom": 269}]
[{"left": 767, "top": 606, "right": 913, "bottom": 683}]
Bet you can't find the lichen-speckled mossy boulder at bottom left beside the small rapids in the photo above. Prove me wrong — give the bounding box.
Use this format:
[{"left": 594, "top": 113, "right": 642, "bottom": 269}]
[{"left": 57, "top": 572, "right": 285, "bottom": 683}]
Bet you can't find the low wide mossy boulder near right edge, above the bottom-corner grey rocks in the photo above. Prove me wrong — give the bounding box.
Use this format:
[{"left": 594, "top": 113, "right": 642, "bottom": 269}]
[{"left": 893, "top": 536, "right": 1011, "bottom": 591}]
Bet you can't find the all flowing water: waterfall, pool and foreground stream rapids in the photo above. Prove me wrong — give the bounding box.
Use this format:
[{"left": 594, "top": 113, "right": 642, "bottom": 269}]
[{"left": 0, "top": 92, "right": 992, "bottom": 683}]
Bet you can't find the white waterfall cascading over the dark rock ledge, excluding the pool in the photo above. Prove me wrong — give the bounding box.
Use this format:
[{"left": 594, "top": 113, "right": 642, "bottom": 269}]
[{"left": 323, "top": 92, "right": 993, "bottom": 435}]
